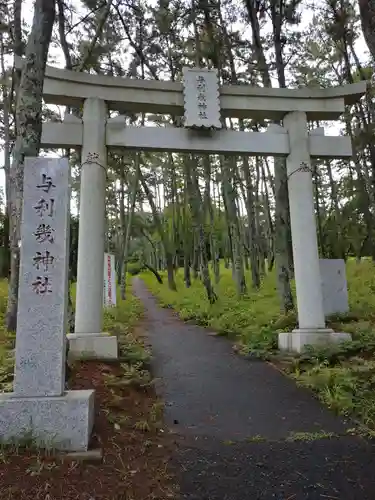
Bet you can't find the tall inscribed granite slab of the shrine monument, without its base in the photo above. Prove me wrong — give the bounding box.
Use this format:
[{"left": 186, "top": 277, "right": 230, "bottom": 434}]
[{"left": 14, "top": 158, "right": 70, "bottom": 397}]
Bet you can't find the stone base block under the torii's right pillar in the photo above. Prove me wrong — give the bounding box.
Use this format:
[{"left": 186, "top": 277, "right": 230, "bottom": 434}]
[{"left": 279, "top": 328, "right": 352, "bottom": 353}]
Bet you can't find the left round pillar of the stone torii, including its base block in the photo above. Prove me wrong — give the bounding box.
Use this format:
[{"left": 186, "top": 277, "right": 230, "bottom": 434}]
[{"left": 68, "top": 97, "right": 117, "bottom": 358}]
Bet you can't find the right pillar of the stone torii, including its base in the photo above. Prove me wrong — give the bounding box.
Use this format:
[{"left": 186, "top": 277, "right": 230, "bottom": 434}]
[{"left": 279, "top": 111, "right": 351, "bottom": 352}]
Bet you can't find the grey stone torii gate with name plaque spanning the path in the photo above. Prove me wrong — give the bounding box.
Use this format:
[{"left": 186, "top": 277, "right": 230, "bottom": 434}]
[{"left": 23, "top": 58, "right": 366, "bottom": 357}]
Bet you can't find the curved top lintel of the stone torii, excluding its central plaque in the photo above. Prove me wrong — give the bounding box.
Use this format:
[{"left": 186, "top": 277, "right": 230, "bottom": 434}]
[{"left": 16, "top": 58, "right": 366, "bottom": 121}]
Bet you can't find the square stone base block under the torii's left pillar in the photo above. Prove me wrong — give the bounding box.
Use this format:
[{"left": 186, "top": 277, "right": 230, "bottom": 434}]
[{"left": 67, "top": 333, "right": 118, "bottom": 359}]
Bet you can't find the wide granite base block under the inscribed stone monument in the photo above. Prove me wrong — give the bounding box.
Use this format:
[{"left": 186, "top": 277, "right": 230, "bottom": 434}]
[{"left": 0, "top": 390, "right": 95, "bottom": 451}]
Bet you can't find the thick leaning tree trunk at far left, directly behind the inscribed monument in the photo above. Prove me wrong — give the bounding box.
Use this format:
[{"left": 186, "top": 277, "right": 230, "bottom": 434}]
[{"left": 6, "top": 0, "right": 55, "bottom": 331}]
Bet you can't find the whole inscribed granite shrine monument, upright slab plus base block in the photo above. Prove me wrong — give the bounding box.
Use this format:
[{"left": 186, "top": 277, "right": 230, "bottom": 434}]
[{"left": 0, "top": 158, "right": 94, "bottom": 450}]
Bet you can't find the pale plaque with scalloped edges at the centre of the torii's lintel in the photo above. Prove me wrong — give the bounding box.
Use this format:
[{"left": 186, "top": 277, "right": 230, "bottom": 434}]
[{"left": 182, "top": 68, "right": 222, "bottom": 129}]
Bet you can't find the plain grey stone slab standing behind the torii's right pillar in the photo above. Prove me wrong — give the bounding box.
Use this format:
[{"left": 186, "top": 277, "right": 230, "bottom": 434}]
[{"left": 319, "top": 259, "right": 349, "bottom": 316}]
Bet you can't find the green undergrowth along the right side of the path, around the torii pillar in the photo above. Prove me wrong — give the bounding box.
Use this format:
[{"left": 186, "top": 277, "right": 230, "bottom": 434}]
[{"left": 142, "top": 259, "right": 375, "bottom": 429}]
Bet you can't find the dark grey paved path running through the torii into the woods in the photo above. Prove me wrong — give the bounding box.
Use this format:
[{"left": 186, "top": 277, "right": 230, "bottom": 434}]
[{"left": 133, "top": 278, "right": 375, "bottom": 500}]
